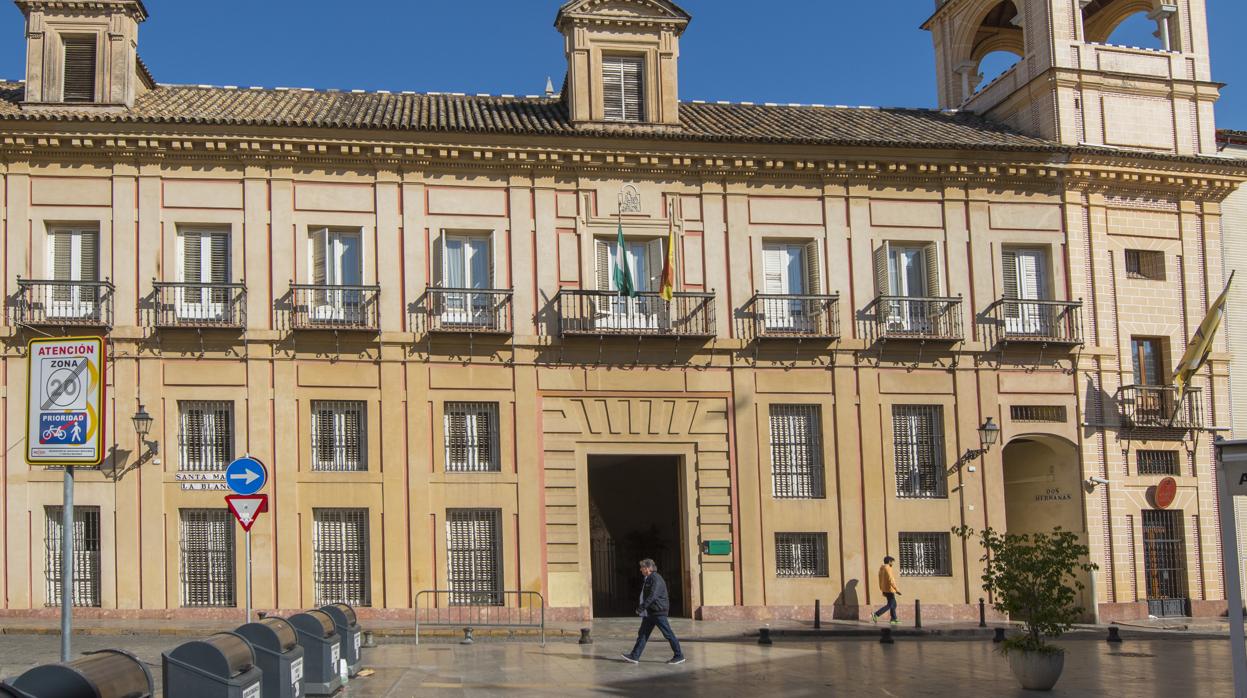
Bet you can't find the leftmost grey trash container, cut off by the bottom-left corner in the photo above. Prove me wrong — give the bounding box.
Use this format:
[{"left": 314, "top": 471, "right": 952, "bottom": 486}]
[{"left": 0, "top": 649, "right": 152, "bottom": 698}]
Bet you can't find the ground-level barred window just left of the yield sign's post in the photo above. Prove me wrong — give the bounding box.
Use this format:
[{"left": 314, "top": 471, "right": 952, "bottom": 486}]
[{"left": 180, "top": 509, "right": 234, "bottom": 607}]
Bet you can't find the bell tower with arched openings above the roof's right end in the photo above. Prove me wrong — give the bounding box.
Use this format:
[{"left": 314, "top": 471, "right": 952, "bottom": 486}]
[{"left": 923, "top": 0, "right": 1220, "bottom": 155}]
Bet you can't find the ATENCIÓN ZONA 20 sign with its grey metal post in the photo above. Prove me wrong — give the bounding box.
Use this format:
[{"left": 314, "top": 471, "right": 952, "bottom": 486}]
[{"left": 26, "top": 337, "right": 105, "bottom": 662}]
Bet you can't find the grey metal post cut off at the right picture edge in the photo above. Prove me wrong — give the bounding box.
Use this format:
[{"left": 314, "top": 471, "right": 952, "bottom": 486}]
[{"left": 1216, "top": 439, "right": 1247, "bottom": 698}]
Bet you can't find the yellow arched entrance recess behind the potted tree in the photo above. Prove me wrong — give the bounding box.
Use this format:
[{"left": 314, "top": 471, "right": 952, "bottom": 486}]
[{"left": 1003, "top": 434, "right": 1091, "bottom": 613}]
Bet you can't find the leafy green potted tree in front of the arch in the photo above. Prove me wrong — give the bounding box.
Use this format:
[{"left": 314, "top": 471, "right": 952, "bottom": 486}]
[{"left": 953, "top": 526, "right": 1096, "bottom": 691}]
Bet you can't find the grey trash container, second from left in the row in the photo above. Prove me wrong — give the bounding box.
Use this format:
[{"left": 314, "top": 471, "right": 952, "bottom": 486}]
[{"left": 161, "top": 632, "right": 262, "bottom": 698}]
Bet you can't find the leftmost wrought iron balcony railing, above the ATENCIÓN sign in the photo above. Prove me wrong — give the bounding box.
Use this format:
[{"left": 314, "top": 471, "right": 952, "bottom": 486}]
[{"left": 9, "top": 278, "right": 115, "bottom": 329}]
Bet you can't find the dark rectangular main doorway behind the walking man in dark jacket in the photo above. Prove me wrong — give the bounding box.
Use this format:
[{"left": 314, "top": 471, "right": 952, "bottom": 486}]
[{"left": 589, "top": 456, "right": 687, "bottom": 618}]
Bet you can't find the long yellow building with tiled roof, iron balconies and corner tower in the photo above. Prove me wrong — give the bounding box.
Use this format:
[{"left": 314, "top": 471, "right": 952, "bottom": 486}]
[{"left": 0, "top": 0, "right": 1247, "bottom": 619}]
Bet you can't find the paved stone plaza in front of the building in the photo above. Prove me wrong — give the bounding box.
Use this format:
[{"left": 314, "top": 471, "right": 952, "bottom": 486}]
[{"left": 0, "top": 634, "right": 1232, "bottom": 698}]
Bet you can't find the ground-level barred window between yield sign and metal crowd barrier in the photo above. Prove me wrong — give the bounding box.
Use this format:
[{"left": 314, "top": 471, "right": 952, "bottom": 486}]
[{"left": 312, "top": 509, "right": 372, "bottom": 606}]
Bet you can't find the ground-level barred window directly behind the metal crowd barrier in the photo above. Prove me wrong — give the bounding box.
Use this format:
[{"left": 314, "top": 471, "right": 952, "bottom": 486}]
[{"left": 446, "top": 509, "right": 503, "bottom": 606}]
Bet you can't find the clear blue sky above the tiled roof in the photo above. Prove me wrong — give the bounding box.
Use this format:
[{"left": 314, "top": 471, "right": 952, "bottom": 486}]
[{"left": 0, "top": 0, "right": 1247, "bottom": 130}]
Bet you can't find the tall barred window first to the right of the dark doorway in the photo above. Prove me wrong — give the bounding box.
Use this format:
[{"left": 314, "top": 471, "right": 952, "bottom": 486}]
[{"left": 771, "top": 405, "right": 824, "bottom": 500}]
